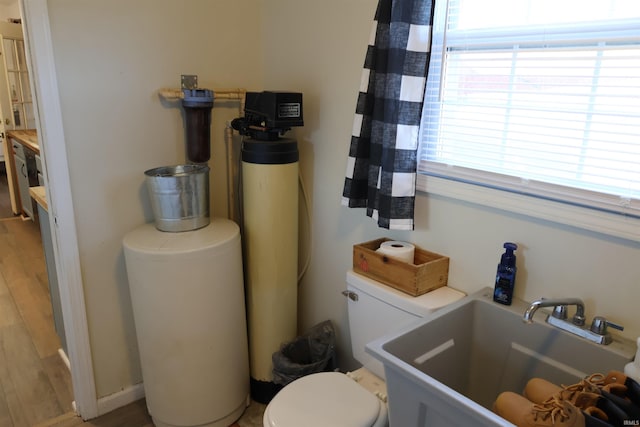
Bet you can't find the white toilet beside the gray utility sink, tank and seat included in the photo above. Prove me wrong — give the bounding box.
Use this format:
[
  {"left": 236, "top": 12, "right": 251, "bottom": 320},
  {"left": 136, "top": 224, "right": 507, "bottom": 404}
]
[{"left": 263, "top": 271, "right": 465, "bottom": 427}]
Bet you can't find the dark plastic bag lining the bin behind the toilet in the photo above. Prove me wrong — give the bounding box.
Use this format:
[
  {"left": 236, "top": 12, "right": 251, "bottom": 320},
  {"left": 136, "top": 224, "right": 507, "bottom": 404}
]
[{"left": 271, "top": 320, "right": 336, "bottom": 386}]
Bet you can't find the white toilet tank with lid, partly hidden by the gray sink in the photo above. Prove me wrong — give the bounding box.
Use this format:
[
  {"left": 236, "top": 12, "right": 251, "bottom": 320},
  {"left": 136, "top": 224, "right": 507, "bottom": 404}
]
[{"left": 347, "top": 270, "right": 465, "bottom": 378}]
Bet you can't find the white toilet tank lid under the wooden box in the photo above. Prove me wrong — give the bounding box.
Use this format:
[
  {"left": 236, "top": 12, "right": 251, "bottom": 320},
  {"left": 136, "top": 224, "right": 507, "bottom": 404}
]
[{"left": 347, "top": 270, "right": 466, "bottom": 317}]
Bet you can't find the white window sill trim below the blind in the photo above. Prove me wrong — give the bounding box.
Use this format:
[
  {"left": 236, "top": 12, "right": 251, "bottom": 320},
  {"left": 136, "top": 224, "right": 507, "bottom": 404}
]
[{"left": 416, "top": 174, "right": 640, "bottom": 242}]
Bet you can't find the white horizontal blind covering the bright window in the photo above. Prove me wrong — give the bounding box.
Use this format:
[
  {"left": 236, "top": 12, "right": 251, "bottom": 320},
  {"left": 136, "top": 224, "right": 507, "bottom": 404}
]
[{"left": 419, "top": 0, "right": 640, "bottom": 217}]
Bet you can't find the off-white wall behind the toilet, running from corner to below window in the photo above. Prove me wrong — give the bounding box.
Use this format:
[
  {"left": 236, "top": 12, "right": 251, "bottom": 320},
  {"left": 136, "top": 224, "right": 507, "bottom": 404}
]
[{"left": 264, "top": 0, "right": 640, "bottom": 367}]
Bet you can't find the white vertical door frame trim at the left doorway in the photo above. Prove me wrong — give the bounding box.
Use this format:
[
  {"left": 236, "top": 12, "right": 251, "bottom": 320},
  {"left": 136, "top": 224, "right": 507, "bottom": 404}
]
[{"left": 20, "top": 0, "right": 100, "bottom": 419}]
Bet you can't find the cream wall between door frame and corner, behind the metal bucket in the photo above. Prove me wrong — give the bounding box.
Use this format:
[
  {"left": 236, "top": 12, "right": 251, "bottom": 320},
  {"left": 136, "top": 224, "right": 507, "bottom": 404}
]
[{"left": 45, "top": 0, "right": 263, "bottom": 397}]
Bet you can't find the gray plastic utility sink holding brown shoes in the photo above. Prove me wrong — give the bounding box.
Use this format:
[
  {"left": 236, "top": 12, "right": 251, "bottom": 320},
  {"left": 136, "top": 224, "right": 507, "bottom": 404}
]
[{"left": 367, "top": 288, "right": 635, "bottom": 427}]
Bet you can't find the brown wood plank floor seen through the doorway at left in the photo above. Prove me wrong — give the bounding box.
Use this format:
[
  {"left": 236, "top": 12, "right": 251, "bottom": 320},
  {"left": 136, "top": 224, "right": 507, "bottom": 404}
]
[{"left": 0, "top": 218, "right": 73, "bottom": 427}]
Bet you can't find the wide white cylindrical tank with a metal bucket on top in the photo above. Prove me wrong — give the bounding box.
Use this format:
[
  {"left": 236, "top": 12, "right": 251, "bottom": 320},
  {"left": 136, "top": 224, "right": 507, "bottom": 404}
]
[{"left": 123, "top": 218, "right": 249, "bottom": 427}]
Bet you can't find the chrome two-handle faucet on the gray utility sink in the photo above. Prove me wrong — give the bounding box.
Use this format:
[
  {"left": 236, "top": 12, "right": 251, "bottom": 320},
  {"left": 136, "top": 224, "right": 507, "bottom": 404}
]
[{"left": 522, "top": 298, "right": 624, "bottom": 344}]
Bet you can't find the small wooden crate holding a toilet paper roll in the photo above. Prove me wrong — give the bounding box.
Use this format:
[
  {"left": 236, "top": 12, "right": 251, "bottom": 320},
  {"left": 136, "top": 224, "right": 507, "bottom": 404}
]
[{"left": 353, "top": 238, "right": 449, "bottom": 296}]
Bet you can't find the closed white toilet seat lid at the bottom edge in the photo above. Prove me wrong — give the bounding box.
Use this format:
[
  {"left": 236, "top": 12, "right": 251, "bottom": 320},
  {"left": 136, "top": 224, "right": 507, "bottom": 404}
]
[{"left": 264, "top": 372, "right": 387, "bottom": 427}]
